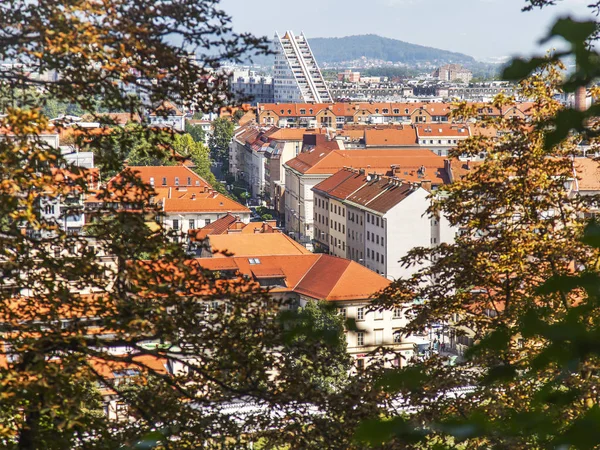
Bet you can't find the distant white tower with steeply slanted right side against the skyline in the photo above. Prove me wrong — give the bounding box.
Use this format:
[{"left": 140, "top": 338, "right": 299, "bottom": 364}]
[{"left": 273, "top": 31, "right": 333, "bottom": 103}]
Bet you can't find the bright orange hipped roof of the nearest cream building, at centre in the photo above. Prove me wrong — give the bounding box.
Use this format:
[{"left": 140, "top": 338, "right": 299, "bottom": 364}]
[{"left": 197, "top": 253, "right": 390, "bottom": 301}]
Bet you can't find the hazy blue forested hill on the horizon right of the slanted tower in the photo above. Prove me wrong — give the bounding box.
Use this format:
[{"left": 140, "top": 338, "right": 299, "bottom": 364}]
[{"left": 308, "top": 34, "right": 475, "bottom": 64}]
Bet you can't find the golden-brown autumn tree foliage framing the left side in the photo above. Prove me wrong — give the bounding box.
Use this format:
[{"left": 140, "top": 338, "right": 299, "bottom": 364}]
[{"left": 0, "top": 0, "right": 392, "bottom": 450}]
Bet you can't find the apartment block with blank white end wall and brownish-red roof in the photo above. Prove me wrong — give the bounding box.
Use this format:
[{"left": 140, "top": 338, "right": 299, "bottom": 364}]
[{"left": 313, "top": 168, "right": 456, "bottom": 279}]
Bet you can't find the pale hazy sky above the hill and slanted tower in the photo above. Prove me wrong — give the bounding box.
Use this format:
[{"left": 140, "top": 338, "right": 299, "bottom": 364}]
[{"left": 221, "top": 0, "right": 590, "bottom": 59}]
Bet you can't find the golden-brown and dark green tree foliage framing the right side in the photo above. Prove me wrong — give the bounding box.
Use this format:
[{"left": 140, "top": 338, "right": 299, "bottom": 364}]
[{"left": 357, "top": 1, "right": 600, "bottom": 449}]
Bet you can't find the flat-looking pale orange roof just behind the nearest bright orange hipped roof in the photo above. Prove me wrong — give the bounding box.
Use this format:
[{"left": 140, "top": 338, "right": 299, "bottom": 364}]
[{"left": 208, "top": 233, "right": 310, "bottom": 257}]
